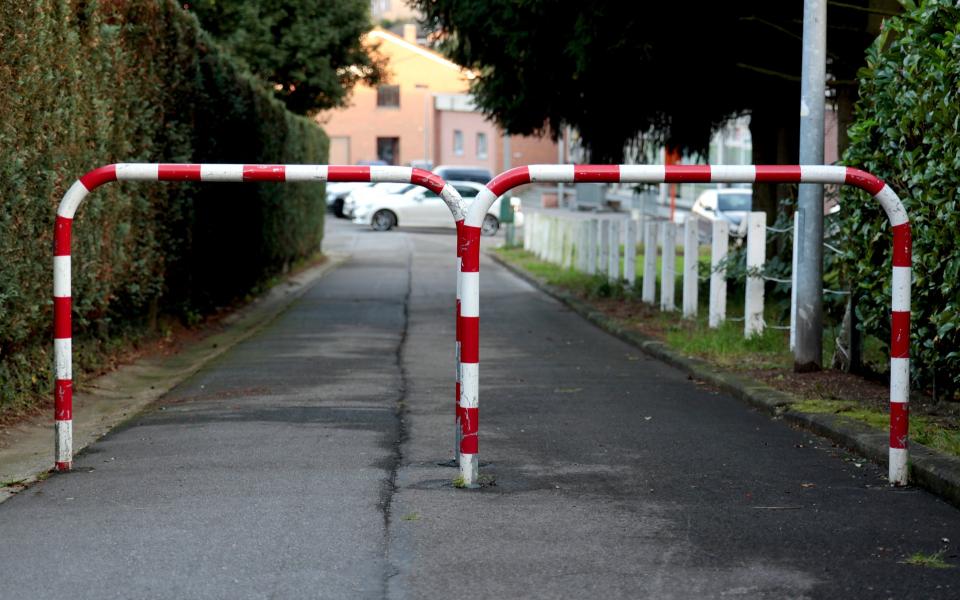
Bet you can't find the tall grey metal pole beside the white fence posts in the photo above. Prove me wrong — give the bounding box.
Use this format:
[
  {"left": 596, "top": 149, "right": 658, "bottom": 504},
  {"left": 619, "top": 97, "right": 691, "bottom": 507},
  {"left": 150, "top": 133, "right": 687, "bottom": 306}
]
[{"left": 793, "top": 0, "right": 827, "bottom": 372}]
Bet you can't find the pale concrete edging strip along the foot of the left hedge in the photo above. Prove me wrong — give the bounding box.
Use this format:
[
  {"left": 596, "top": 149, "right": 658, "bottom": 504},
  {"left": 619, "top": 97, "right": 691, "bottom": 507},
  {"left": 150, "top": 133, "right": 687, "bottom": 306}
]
[{"left": 0, "top": 254, "right": 349, "bottom": 502}]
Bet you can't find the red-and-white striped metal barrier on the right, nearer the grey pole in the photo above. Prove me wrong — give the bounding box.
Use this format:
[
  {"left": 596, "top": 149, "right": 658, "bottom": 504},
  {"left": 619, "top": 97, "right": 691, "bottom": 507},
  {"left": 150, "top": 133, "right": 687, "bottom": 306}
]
[{"left": 460, "top": 165, "right": 911, "bottom": 485}]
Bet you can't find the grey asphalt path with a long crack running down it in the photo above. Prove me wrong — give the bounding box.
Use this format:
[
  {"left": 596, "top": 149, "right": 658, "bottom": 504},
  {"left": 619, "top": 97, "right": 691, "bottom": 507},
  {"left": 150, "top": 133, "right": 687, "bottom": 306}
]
[{"left": 0, "top": 222, "right": 960, "bottom": 598}]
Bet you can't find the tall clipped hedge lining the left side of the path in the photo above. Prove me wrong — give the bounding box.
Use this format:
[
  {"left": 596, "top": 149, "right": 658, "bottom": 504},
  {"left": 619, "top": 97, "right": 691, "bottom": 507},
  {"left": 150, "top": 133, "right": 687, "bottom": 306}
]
[{"left": 0, "top": 0, "right": 327, "bottom": 412}]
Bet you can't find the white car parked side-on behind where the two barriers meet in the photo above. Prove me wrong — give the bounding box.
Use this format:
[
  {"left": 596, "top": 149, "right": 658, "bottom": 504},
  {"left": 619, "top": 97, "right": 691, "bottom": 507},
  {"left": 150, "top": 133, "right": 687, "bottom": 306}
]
[{"left": 344, "top": 181, "right": 523, "bottom": 235}]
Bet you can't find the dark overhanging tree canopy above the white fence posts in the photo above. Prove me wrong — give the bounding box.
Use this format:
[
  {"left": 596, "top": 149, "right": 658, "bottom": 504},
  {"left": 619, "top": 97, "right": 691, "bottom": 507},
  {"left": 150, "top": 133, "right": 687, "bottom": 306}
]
[{"left": 415, "top": 0, "right": 889, "bottom": 162}]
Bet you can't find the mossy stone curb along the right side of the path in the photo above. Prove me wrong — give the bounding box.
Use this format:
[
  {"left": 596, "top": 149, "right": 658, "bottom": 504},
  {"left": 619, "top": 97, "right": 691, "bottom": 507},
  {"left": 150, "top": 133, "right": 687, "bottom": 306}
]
[{"left": 485, "top": 251, "right": 960, "bottom": 507}]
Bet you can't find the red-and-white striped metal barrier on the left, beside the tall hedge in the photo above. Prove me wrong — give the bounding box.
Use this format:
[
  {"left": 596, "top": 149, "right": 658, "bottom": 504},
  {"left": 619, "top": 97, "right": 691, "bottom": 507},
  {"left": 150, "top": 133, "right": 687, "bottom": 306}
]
[{"left": 53, "top": 163, "right": 466, "bottom": 471}]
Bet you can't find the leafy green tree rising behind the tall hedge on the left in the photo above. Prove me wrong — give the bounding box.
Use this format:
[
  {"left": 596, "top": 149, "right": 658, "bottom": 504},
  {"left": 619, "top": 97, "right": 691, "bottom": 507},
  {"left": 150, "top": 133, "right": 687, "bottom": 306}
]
[{"left": 189, "top": 0, "right": 383, "bottom": 114}]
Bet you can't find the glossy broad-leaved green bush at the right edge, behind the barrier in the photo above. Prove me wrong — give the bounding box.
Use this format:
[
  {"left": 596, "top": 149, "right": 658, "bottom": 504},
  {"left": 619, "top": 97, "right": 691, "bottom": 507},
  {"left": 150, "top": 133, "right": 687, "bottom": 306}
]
[{"left": 841, "top": 0, "right": 960, "bottom": 397}]
